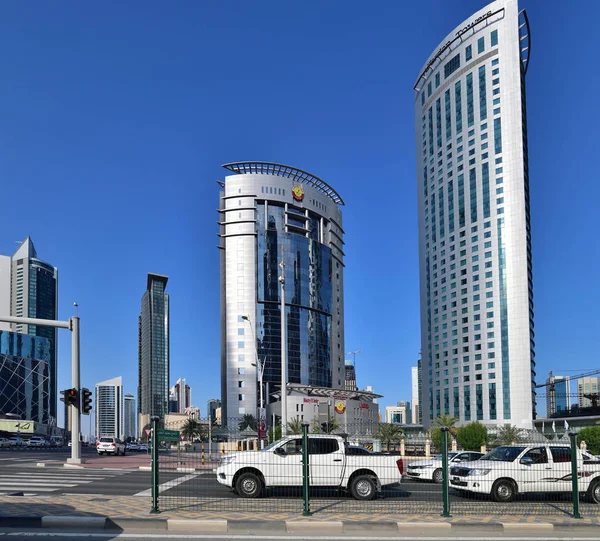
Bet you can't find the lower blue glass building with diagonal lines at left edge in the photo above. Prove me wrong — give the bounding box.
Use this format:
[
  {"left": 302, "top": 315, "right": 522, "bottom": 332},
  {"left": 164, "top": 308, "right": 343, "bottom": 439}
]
[{"left": 0, "top": 331, "right": 52, "bottom": 425}]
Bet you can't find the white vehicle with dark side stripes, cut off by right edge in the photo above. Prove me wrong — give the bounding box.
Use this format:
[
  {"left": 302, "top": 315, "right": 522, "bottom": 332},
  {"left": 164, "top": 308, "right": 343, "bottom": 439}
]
[{"left": 450, "top": 444, "right": 600, "bottom": 503}]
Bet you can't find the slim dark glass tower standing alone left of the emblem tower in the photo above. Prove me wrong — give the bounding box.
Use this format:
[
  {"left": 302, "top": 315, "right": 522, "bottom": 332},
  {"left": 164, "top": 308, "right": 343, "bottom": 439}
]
[{"left": 138, "top": 273, "right": 170, "bottom": 432}]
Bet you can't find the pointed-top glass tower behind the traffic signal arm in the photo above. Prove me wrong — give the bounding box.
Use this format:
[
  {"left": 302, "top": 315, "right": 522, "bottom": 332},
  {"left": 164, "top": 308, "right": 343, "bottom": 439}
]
[{"left": 0, "top": 237, "right": 58, "bottom": 422}]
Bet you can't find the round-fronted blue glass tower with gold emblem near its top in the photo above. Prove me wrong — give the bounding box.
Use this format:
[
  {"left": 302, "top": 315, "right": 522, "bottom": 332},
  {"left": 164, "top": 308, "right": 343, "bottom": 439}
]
[{"left": 219, "top": 162, "right": 345, "bottom": 423}]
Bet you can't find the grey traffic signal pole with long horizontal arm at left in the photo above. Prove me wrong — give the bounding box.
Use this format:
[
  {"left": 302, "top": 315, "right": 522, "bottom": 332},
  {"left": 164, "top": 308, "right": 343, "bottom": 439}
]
[{"left": 0, "top": 316, "right": 82, "bottom": 464}]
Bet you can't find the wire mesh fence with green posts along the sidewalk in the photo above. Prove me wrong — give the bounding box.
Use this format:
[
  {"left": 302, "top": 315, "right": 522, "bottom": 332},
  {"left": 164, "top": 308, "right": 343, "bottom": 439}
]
[{"left": 146, "top": 419, "right": 600, "bottom": 518}]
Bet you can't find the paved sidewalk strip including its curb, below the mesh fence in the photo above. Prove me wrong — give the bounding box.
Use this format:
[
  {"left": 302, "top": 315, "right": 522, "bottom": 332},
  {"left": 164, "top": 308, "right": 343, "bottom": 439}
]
[{"left": 0, "top": 495, "right": 600, "bottom": 533}]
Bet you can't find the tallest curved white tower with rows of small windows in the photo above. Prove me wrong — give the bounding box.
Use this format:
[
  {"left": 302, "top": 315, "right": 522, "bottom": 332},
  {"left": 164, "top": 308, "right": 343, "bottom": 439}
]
[{"left": 414, "top": 0, "right": 535, "bottom": 428}]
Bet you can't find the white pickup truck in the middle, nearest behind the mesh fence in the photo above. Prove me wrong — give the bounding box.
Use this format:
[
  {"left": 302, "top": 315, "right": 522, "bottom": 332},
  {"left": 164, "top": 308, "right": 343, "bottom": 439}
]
[{"left": 217, "top": 434, "right": 404, "bottom": 500}]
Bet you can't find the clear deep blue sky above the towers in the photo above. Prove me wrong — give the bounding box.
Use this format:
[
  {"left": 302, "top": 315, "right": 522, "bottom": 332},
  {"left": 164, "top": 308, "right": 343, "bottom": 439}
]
[{"left": 0, "top": 0, "right": 600, "bottom": 431}]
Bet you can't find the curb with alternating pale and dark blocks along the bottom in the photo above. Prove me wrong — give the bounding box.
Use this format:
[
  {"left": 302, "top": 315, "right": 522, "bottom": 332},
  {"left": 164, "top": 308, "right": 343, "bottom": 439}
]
[{"left": 0, "top": 516, "right": 598, "bottom": 535}]
